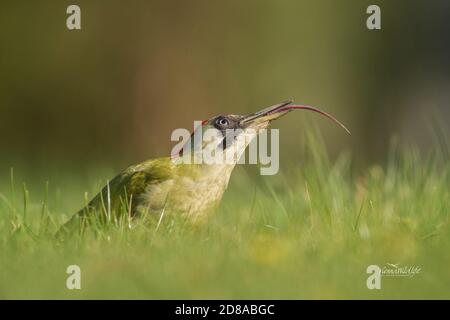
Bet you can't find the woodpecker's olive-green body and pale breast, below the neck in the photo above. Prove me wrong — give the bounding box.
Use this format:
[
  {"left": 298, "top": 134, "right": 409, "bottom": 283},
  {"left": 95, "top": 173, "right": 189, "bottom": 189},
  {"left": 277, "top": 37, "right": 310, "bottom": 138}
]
[{"left": 58, "top": 157, "right": 233, "bottom": 235}]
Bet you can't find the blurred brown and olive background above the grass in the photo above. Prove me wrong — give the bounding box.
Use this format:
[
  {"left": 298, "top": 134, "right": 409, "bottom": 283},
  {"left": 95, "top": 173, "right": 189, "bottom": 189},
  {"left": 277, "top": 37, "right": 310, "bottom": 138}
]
[{"left": 0, "top": 0, "right": 450, "bottom": 179}]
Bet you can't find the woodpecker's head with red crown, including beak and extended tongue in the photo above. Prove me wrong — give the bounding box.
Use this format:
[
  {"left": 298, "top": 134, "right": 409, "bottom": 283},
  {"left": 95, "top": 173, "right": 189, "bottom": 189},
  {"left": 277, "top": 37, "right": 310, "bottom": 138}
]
[{"left": 174, "top": 101, "right": 350, "bottom": 164}]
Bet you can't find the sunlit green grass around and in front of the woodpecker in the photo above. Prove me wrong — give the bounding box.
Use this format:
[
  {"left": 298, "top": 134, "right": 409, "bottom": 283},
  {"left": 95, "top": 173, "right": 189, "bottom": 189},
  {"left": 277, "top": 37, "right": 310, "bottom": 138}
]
[{"left": 0, "top": 129, "right": 450, "bottom": 299}]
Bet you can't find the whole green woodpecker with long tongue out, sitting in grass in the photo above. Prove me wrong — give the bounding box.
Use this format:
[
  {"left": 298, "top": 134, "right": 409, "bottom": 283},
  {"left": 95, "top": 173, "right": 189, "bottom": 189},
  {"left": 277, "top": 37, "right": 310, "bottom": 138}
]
[{"left": 57, "top": 101, "right": 350, "bottom": 237}]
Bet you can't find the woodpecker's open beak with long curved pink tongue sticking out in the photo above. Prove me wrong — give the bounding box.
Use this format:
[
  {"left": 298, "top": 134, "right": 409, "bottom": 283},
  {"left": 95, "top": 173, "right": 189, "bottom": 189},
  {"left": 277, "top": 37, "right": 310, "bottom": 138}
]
[{"left": 240, "top": 101, "right": 350, "bottom": 134}]
